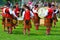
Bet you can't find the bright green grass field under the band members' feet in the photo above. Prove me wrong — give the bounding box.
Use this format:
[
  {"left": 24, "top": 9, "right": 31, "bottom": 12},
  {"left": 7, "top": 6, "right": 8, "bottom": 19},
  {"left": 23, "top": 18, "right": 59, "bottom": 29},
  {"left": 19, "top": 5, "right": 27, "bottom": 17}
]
[{"left": 0, "top": 16, "right": 60, "bottom": 40}]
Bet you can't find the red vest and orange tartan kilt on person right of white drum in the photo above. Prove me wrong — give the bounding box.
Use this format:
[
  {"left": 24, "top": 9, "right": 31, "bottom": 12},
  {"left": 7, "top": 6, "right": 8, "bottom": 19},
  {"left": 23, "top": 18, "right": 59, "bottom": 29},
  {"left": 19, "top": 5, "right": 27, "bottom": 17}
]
[{"left": 44, "top": 8, "right": 53, "bottom": 27}]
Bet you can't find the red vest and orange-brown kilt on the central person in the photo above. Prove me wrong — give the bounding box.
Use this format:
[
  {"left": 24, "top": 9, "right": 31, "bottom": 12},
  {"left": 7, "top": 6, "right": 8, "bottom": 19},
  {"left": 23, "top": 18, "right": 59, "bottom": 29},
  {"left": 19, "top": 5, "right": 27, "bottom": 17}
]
[{"left": 24, "top": 10, "right": 31, "bottom": 29}]
